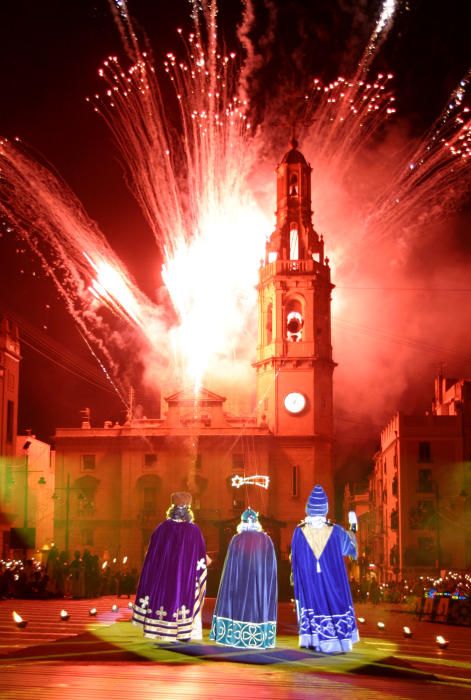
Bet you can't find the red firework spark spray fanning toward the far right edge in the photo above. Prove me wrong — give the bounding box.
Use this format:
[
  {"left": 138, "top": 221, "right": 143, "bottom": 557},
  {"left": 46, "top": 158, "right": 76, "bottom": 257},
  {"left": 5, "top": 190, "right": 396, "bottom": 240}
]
[{"left": 367, "top": 71, "right": 471, "bottom": 240}]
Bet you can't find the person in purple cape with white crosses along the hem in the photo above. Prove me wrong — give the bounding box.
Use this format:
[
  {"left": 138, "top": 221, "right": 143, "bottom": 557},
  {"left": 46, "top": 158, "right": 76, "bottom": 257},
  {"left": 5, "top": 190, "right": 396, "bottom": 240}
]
[{"left": 132, "top": 492, "right": 207, "bottom": 642}]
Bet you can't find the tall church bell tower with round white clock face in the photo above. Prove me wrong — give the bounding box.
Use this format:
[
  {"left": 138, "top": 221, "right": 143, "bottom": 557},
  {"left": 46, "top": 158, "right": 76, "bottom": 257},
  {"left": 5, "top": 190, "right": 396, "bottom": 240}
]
[{"left": 255, "top": 139, "right": 335, "bottom": 521}]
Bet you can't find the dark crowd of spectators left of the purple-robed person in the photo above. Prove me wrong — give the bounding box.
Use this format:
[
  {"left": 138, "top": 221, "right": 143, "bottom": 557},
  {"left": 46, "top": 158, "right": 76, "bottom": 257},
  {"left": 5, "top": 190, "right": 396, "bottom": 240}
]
[{"left": 0, "top": 547, "right": 138, "bottom": 599}]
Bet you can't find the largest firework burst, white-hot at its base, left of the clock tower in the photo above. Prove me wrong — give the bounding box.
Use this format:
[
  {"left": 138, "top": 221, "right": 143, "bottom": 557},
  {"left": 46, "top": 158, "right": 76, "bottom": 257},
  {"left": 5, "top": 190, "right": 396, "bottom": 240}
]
[{"left": 93, "top": 0, "right": 269, "bottom": 386}]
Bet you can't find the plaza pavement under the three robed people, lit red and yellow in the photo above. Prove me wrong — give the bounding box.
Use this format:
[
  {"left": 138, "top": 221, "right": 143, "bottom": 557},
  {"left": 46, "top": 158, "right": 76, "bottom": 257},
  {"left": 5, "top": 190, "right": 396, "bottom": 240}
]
[{"left": 0, "top": 596, "right": 471, "bottom": 700}]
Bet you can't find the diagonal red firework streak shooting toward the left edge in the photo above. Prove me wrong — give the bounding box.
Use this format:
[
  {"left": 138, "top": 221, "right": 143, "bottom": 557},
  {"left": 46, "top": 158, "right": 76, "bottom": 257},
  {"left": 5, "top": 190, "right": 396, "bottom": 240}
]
[{"left": 0, "top": 139, "right": 162, "bottom": 402}]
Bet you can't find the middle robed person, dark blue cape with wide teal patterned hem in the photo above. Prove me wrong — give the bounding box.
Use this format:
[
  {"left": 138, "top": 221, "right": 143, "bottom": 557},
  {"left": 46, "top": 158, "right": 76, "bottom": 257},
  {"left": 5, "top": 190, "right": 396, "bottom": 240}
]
[{"left": 210, "top": 508, "right": 278, "bottom": 649}]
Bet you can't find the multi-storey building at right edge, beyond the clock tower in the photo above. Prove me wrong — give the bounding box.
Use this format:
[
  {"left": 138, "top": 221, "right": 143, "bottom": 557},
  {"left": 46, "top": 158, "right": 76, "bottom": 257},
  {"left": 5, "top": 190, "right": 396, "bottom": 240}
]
[{"left": 368, "top": 376, "right": 471, "bottom": 581}]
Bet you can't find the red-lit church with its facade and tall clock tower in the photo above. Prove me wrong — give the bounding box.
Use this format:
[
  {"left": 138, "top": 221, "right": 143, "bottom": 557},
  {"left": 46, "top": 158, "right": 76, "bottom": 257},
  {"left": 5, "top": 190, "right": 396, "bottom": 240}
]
[{"left": 55, "top": 141, "right": 335, "bottom": 576}]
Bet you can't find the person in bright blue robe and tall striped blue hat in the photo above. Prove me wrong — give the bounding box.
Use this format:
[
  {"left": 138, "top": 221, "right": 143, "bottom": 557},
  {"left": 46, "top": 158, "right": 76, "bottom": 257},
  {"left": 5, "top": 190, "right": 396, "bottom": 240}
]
[{"left": 291, "top": 485, "right": 359, "bottom": 654}]
